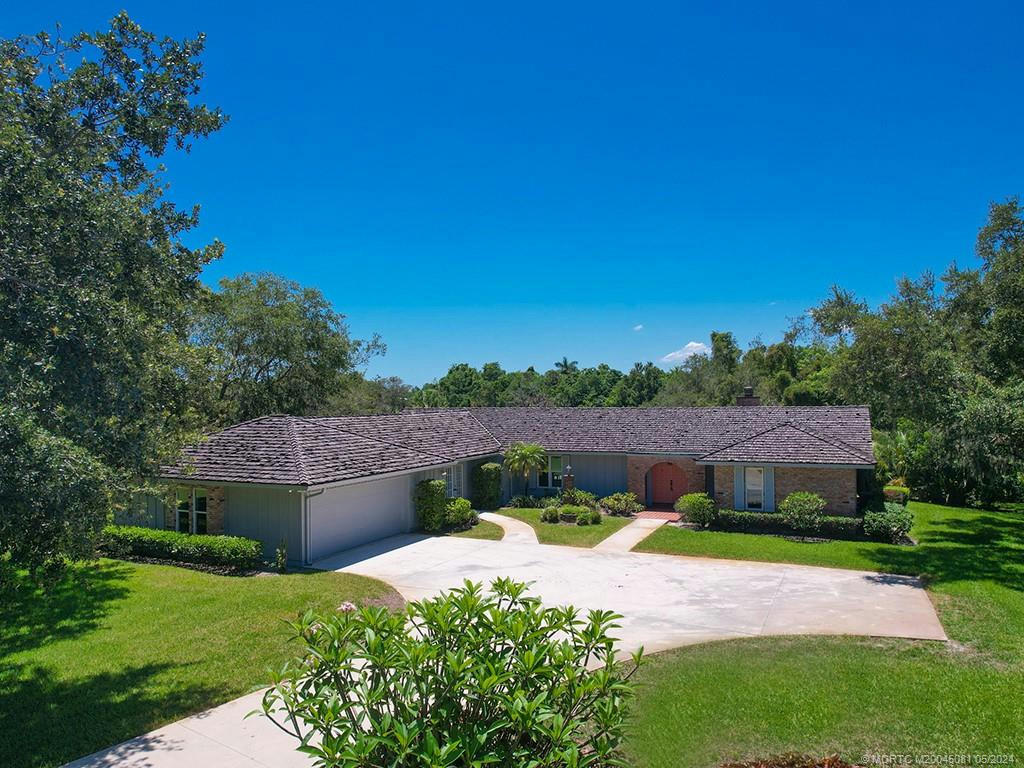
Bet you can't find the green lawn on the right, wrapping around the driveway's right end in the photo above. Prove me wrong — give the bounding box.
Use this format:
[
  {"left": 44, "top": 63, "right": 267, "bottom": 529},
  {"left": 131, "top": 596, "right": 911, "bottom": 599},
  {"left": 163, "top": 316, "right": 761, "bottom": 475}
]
[{"left": 629, "top": 504, "right": 1024, "bottom": 768}]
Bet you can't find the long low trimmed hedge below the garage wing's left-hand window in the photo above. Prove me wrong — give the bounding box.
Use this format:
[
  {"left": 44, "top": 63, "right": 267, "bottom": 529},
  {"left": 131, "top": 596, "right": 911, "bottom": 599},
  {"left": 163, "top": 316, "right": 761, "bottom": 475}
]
[{"left": 100, "top": 525, "right": 263, "bottom": 569}]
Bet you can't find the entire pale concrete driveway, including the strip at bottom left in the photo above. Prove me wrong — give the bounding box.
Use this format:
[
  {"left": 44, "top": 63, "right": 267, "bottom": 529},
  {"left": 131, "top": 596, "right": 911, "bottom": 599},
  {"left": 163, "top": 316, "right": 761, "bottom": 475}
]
[{"left": 64, "top": 532, "right": 946, "bottom": 768}]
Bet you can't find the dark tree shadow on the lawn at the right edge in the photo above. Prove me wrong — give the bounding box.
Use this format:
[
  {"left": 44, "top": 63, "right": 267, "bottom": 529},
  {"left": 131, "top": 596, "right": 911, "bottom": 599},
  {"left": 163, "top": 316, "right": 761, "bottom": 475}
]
[{"left": 861, "top": 510, "right": 1024, "bottom": 592}]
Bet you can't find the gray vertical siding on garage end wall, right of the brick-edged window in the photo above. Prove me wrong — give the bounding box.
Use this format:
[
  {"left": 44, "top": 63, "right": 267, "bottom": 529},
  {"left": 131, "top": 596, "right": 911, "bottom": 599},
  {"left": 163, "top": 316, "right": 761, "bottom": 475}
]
[{"left": 224, "top": 485, "right": 302, "bottom": 562}]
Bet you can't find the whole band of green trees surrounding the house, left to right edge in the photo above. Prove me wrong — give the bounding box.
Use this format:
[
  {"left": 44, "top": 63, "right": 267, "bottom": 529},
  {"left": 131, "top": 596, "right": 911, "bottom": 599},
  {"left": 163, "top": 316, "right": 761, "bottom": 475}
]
[{"left": 0, "top": 13, "right": 1024, "bottom": 570}]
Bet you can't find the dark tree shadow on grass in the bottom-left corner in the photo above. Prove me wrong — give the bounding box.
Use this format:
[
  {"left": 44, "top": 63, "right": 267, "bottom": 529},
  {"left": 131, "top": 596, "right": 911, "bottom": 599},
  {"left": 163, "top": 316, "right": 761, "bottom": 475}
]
[{"left": 0, "top": 664, "right": 218, "bottom": 768}]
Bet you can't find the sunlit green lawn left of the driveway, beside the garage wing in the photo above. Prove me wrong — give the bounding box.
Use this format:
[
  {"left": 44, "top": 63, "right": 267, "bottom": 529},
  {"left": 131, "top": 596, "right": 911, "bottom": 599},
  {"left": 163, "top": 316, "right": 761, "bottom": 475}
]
[{"left": 0, "top": 560, "right": 400, "bottom": 766}]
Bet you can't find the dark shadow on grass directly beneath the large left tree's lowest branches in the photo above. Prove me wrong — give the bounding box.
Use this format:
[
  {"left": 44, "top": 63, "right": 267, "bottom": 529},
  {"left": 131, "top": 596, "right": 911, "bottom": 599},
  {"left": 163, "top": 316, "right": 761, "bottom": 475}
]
[{"left": 0, "top": 561, "right": 131, "bottom": 659}]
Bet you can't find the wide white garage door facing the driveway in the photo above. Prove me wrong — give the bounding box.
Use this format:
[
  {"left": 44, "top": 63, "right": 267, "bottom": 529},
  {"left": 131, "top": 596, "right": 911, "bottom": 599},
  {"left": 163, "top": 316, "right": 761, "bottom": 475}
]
[{"left": 309, "top": 475, "right": 413, "bottom": 560}]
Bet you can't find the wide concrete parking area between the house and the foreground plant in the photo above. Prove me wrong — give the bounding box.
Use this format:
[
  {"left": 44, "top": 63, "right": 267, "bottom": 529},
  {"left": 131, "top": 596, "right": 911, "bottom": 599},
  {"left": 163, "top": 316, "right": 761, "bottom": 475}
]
[{"left": 315, "top": 534, "right": 946, "bottom": 651}]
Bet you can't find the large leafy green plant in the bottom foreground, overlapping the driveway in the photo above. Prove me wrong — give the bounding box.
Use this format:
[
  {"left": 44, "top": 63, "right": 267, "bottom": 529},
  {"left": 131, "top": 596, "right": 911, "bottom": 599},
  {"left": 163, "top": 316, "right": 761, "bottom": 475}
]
[{"left": 263, "top": 579, "right": 640, "bottom": 768}]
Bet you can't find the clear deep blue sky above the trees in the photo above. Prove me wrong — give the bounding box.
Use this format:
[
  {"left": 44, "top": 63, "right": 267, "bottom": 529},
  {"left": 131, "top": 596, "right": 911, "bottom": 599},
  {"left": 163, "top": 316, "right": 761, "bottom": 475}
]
[{"left": 0, "top": 0, "right": 1024, "bottom": 384}]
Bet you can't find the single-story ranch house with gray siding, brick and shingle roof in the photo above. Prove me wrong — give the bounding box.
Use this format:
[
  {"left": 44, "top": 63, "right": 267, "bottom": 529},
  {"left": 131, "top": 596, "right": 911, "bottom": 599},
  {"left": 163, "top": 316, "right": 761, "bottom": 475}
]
[{"left": 121, "top": 396, "right": 874, "bottom": 563}]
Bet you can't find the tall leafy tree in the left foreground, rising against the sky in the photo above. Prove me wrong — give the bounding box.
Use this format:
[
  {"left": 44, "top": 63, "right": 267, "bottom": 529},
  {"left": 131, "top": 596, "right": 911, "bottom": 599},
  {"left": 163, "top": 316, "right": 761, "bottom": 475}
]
[{"left": 0, "top": 12, "right": 225, "bottom": 569}]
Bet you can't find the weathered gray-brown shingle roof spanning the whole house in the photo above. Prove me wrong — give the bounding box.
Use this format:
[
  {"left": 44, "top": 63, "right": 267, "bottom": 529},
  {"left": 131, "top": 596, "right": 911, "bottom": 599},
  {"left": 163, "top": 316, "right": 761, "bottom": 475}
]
[{"left": 161, "top": 406, "right": 874, "bottom": 486}]
